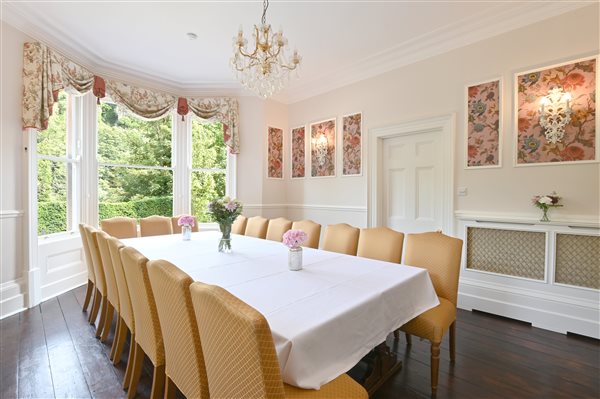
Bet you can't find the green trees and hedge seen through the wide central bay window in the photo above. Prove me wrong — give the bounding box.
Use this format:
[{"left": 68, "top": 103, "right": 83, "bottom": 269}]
[{"left": 98, "top": 102, "right": 173, "bottom": 220}]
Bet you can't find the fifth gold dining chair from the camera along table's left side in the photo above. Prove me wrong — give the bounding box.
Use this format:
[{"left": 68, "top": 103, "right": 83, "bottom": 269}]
[{"left": 93, "top": 231, "right": 120, "bottom": 343}]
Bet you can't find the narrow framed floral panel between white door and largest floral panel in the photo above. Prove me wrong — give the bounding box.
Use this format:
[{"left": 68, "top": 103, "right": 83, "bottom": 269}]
[{"left": 465, "top": 78, "right": 502, "bottom": 169}]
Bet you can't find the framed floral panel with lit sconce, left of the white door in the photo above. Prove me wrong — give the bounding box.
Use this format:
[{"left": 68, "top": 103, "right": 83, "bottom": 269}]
[{"left": 310, "top": 118, "right": 336, "bottom": 177}]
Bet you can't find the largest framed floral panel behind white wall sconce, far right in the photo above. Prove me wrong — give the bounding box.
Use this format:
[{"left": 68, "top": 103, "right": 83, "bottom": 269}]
[{"left": 515, "top": 56, "right": 600, "bottom": 166}]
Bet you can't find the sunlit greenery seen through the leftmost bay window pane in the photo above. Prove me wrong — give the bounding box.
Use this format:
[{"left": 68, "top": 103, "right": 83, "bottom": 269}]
[{"left": 37, "top": 91, "right": 76, "bottom": 235}]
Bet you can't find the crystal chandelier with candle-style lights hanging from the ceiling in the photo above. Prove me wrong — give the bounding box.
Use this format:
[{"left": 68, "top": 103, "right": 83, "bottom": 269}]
[{"left": 231, "top": 0, "right": 302, "bottom": 98}]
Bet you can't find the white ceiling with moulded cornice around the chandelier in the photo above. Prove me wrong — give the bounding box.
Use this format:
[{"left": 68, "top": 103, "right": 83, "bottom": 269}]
[{"left": 2, "top": 0, "right": 589, "bottom": 102}]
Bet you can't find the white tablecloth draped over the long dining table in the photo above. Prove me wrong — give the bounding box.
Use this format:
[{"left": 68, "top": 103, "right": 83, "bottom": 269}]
[{"left": 122, "top": 232, "right": 439, "bottom": 389}]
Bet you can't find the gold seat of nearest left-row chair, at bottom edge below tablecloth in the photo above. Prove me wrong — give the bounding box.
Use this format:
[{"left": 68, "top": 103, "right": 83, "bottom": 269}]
[{"left": 283, "top": 374, "right": 369, "bottom": 399}]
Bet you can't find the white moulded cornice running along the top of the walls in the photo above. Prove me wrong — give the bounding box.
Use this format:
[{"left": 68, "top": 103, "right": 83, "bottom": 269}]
[{"left": 1, "top": 1, "right": 592, "bottom": 104}]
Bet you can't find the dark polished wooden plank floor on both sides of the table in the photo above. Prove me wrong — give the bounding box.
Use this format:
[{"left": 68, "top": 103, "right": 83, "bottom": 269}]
[{"left": 0, "top": 288, "right": 600, "bottom": 399}]
